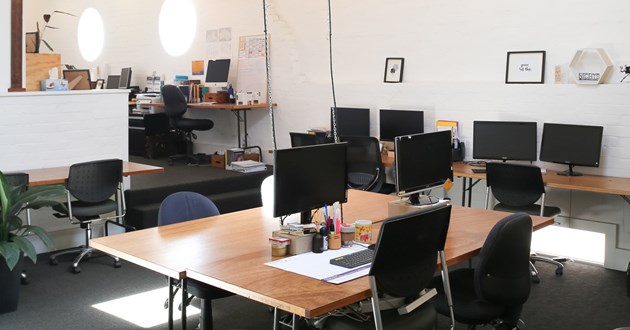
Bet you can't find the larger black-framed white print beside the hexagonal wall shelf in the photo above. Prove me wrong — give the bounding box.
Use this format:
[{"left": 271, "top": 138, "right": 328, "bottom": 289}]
[{"left": 505, "top": 50, "right": 545, "bottom": 84}]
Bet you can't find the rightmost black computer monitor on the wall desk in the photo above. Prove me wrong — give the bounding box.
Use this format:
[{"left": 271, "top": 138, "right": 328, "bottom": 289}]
[{"left": 540, "top": 123, "right": 604, "bottom": 176}]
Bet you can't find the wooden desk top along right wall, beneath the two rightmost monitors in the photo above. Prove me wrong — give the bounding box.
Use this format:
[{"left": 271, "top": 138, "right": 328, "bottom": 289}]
[{"left": 453, "top": 162, "right": 630, "bottom": 196}]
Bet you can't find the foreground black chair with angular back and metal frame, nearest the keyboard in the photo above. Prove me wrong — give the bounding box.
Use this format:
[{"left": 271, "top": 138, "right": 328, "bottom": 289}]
[{"left": 325, "top": 205, "right": 451, "bottom": 330}]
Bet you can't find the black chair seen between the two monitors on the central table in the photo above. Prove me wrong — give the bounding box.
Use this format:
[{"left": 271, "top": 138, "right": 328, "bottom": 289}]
[{"left": 340, "top": 136, "right": 385, "bottom": 192}]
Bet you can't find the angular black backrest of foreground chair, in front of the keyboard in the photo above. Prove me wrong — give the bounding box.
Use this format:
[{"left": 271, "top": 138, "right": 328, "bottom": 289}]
[{"left": 369, "top": 205, "right": 451, "bottom": 297}]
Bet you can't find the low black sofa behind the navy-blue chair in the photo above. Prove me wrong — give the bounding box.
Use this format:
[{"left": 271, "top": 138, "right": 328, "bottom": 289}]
[{"left": 125, "top": 168, "right": 273, "bottom": 229}]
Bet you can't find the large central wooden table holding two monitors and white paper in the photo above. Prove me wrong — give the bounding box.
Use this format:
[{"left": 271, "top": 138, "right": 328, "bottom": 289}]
[{"left": 91, "top": 190, "right": 553, "bottom": 318}]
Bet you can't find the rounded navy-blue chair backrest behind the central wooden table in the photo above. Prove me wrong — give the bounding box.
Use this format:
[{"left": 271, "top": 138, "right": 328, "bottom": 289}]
[{"left": 158, "top": 191, "right": 220, "bottom": 226}]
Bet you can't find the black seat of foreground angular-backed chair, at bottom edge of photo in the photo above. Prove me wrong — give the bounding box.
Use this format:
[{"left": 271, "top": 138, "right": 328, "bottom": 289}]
[{"left": 324, "top": 302, "right": 437, "bottom": 330}]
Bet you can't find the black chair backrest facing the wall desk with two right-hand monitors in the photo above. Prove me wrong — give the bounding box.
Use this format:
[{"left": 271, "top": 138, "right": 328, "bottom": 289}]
[{"left": 486, "top": 163, "right": 545, "bottom": 207}]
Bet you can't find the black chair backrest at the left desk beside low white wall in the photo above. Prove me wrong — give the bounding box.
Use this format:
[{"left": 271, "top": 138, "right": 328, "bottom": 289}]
[{"left": 67, "top": 159, "right": 122, "bottom": 203}]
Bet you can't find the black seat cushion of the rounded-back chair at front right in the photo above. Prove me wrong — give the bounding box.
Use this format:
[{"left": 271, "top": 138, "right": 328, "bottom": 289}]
[{"left": 431, "top": 268, "right": 506, "bottom": 324}]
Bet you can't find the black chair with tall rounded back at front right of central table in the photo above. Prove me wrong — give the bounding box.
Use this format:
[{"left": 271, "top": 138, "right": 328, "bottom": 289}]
[{"left": 432, "top": 213, "right": 532, "bottom": 330}]
